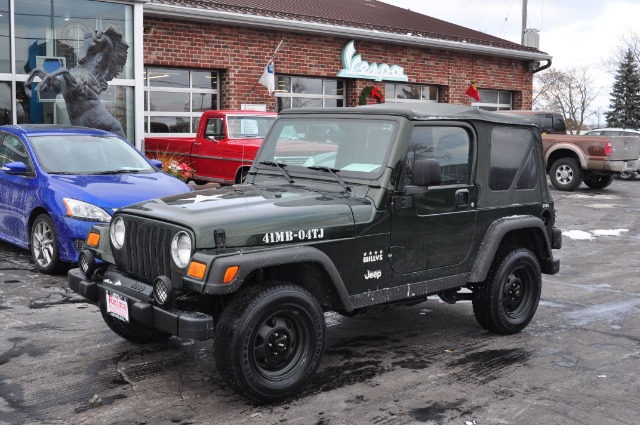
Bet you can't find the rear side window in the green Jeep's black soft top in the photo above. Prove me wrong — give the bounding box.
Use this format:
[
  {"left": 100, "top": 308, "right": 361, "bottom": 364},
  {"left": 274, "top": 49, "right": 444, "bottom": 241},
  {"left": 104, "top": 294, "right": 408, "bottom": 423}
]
[{"left": 489, "top": 127, "right": 538, "bottom": 191}]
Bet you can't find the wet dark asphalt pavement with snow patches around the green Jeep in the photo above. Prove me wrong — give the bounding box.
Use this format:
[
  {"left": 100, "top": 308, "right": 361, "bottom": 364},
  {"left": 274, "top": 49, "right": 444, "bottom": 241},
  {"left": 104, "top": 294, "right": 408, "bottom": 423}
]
[{"left": 0, "top": 181, "right": 640, "bottom": 425}]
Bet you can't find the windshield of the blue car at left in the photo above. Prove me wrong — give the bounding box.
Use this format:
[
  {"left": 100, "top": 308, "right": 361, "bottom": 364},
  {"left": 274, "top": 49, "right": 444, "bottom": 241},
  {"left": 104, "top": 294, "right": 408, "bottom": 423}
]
[{"left": 29, "top": 134, "right": 155, "bottom": 174}]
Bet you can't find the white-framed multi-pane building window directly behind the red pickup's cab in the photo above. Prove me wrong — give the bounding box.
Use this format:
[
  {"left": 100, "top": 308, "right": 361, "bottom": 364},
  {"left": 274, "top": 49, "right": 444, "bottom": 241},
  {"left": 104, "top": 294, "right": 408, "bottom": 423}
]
[{"left": 144, "top": 67, "right": 220, "bottom": 133}]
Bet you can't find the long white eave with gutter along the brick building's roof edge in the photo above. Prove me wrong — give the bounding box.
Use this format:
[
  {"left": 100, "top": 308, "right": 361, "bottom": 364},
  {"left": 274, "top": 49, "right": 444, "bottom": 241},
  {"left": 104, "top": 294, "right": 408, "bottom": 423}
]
[{"left": 144, "top": 3, "right": 552, "bottom": 61}]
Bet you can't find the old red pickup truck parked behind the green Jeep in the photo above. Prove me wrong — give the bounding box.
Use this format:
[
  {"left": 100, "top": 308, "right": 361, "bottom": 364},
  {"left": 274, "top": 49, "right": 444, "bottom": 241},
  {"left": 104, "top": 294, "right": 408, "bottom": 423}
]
[{"left": 144, "top": 110, "right": 277, "bottom": 185}]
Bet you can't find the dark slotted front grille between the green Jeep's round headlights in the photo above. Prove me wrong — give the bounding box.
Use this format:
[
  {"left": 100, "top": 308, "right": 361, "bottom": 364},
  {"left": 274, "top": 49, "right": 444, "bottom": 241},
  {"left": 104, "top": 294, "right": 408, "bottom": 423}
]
[{"left": 118, "top": 219, "right": 172, "bottom": 282}]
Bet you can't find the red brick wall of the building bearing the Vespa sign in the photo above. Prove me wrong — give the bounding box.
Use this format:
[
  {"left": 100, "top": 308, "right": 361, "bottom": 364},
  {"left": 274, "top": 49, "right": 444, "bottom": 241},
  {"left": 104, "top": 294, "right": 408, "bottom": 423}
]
[{"left": 144, "top": 18, "right": 533, "bottom": 110}]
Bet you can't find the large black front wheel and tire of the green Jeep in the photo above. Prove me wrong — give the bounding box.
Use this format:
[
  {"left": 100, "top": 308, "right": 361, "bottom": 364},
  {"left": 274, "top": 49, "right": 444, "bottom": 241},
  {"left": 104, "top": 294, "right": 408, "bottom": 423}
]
[{"left": 214, "top": 282, "right": 325, "bottom": 401}]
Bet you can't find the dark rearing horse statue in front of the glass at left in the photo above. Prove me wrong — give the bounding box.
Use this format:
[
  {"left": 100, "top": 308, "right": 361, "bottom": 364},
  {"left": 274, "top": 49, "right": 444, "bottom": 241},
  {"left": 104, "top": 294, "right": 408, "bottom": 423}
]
[{"left": 24, "top": 25, "right": 129, "bottom": 137}]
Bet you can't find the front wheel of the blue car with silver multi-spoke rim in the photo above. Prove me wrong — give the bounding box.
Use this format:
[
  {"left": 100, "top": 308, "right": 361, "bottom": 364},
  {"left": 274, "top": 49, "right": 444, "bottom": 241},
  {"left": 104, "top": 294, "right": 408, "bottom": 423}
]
[{"left": 29, "top": 214, "right": 64, "bottom": 274}]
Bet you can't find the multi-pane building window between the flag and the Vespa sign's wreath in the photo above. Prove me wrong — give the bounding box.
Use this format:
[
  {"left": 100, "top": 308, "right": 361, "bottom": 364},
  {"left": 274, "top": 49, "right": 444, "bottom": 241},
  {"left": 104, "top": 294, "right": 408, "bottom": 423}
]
[{"left": 276, "top": 76, "right": 345, "bottom": 112}]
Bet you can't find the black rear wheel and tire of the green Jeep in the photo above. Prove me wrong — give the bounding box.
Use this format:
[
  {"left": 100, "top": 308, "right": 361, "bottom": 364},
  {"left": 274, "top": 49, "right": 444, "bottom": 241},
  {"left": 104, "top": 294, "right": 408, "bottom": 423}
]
[{"left": 473, "top": 248, "right": 542, "bottom": 335}]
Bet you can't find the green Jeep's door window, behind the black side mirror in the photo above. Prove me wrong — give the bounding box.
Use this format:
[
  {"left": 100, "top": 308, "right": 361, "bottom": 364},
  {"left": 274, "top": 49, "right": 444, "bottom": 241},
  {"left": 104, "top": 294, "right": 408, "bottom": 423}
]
[{"left": 405, "top": 126, "right": 470, "bottom": 185}]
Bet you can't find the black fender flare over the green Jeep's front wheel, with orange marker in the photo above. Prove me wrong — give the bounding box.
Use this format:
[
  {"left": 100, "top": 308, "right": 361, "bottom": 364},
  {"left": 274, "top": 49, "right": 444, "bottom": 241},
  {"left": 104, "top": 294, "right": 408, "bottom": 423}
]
[{"left": 199, "top": 246, "right": 353, "bottom": 311}]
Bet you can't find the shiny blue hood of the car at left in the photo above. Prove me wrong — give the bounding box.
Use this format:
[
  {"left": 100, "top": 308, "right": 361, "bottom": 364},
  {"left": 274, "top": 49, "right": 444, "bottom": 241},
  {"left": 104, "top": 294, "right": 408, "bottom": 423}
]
[{"left": 49, "top": 172, "right": 193, "bottom": 214}]
